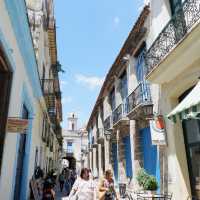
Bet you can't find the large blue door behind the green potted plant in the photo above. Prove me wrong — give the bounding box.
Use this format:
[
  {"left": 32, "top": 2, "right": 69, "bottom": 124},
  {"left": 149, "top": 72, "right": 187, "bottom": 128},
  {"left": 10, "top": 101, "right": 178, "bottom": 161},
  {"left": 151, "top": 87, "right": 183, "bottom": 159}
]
[{"left": 140, "top": 127, "right": 160, "bottom": 188}]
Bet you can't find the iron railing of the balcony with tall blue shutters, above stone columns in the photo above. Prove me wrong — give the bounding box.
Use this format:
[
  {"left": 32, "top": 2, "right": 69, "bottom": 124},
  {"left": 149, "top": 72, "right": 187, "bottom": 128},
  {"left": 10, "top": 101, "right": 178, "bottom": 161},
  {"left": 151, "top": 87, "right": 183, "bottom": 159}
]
[{"left": 127, "top": 81, "right": 152, "bottom": 113}]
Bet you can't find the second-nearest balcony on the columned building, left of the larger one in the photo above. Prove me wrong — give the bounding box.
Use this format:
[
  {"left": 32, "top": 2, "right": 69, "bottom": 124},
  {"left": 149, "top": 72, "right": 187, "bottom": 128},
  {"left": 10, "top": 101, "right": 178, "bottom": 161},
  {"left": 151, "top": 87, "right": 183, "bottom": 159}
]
[{"left": 112, "top": 98, "right": 129, "bottom": 127}]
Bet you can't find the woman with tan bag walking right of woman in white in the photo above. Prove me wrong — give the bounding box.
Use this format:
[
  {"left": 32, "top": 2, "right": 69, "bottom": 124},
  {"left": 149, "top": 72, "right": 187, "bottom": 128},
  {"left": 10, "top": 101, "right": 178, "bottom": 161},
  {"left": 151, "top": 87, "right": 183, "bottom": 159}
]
[{"left": 98, "top": 170, "right": 119, "bottom": 200}]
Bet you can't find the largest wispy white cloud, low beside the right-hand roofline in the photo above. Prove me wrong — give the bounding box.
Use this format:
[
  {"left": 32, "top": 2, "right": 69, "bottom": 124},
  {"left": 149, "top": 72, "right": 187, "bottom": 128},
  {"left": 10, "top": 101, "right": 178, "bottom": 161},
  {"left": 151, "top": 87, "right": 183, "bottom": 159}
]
[{"left": 75, "top": 74, "right": 104, "bottom": 90}]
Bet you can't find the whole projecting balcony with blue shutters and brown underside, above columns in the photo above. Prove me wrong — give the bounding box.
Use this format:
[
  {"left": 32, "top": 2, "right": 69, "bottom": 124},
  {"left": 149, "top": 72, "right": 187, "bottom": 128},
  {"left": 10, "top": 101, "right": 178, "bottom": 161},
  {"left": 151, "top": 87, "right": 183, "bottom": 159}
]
[{"left": 127, "top": 82, "right": 153, "bottom": 119}]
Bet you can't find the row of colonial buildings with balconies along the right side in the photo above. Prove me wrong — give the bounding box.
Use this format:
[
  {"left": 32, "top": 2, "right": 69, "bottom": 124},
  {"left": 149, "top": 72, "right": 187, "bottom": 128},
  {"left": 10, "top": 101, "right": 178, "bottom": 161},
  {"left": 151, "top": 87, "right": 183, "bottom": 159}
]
[{"left": 87, "top": 0, "right": 200, "bottom": 199}]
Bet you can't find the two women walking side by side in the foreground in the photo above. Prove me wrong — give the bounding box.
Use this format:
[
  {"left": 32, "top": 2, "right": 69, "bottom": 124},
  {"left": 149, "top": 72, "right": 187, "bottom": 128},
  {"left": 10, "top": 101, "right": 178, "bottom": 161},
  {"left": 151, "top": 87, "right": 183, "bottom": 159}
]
[{"left": 68, "top": 168, "right": 118, "bottom": 200}]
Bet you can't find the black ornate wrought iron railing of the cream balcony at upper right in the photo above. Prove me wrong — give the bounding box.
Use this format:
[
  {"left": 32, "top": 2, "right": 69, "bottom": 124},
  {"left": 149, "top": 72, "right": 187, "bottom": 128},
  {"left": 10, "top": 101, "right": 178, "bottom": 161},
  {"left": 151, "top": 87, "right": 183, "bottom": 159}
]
[{"left": 146, "top": 0, "right": 200, "bottom": 75}]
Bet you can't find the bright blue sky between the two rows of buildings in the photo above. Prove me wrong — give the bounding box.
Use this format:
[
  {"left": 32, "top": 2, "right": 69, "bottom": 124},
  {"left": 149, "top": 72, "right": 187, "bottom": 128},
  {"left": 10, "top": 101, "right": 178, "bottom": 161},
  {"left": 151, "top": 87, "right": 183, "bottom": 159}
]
[{"left": 55, "top": 0, "right": 143, "bottom": 128}]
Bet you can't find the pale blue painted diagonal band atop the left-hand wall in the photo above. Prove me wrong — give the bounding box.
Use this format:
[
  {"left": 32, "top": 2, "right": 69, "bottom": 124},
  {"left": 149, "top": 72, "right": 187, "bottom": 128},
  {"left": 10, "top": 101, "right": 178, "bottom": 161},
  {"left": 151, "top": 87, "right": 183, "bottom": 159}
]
[{"left": 4, "top": 0, "right": 42, "bottom": 98}]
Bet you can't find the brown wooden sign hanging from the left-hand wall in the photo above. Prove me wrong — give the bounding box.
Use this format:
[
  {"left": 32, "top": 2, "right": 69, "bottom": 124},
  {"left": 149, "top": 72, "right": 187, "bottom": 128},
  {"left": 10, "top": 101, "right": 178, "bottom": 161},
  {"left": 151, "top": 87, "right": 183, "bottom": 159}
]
[{"left": 7, "top": 118, "right": 28, "bottom": 133}]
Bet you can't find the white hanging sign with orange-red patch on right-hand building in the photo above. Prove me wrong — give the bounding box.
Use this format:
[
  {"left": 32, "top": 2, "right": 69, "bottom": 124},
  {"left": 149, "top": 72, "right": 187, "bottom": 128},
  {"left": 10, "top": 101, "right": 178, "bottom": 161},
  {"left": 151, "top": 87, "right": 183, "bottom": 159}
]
[{"left": 149, "top": 116, "right": 166, "bottom": 145}]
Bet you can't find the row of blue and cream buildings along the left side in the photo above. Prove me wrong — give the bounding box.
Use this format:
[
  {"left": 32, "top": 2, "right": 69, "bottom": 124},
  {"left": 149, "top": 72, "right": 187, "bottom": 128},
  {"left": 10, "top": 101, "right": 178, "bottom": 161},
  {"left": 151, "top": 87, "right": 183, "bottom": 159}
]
[{"left": 0, "top": 0, "right": 62, "bottom": 200}]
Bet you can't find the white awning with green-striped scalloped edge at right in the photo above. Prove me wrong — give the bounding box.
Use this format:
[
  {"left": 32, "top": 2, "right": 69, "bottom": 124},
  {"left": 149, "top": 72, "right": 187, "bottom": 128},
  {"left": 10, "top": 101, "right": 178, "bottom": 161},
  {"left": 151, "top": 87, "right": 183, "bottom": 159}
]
[{"left": 167, "top": 81, "right": 200, "bottom": 122}]
